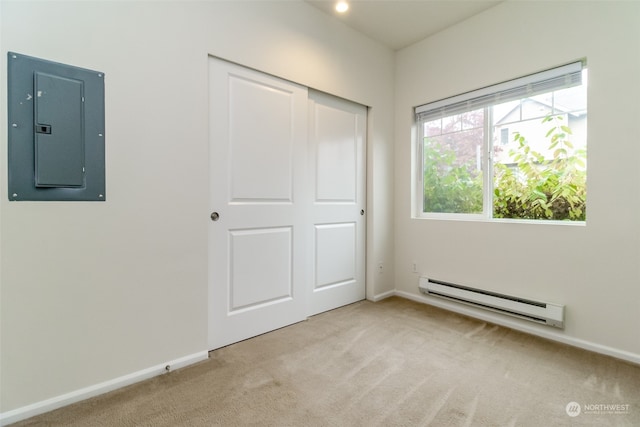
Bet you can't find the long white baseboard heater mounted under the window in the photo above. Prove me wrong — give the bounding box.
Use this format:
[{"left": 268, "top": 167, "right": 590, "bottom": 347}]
[{"left": 419, "top": 277, "right": 564, "bottom": 328}]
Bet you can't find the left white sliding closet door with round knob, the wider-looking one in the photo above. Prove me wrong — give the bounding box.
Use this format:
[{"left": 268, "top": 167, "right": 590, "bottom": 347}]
[{"left": 209, "top": 58, "right": 308, "bottom": 349}]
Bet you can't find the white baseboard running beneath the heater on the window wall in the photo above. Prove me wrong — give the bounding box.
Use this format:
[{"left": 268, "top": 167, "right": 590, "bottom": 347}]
[{"left": 395, "top": 291, "right": 640, "bottom": 364}]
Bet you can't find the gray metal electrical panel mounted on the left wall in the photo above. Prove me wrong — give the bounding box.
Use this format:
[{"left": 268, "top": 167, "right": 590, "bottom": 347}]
[{"left": 7, "top": 52, "right": 106, "bottom": 201}]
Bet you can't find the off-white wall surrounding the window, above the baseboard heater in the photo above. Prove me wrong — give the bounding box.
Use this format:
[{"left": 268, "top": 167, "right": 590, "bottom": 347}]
[{"left": 395, "top": 1, "right": 640, "bottom": 362}]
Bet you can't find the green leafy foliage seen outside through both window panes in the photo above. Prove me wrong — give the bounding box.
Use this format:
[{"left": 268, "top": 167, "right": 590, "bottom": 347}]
[{"left": 423, "top": 116, "right": 587, "bottom": 221}]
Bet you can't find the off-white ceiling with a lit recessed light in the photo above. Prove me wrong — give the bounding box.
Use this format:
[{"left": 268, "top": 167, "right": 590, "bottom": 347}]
[{"left": 305, "top": 0, "right": 502, "bottom": 50}]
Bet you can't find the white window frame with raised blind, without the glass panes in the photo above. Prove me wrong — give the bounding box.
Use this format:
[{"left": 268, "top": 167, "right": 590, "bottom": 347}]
[{"left": 412, "top": 60, "right": 586, "bottom": 225}]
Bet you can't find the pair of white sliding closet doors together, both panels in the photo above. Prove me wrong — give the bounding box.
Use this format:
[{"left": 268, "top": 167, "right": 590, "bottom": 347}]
[{"left": 208, "top": 58, "right": 366, "bottom": 349}]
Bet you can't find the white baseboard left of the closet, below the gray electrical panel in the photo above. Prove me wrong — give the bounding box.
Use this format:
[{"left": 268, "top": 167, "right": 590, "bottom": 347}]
[{"left": 0, "top": 351, "right": 209, "bottom": 426}]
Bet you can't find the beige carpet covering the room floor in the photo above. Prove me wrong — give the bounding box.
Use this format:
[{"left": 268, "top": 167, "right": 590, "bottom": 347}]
[{"left": 11, "top": 298, "right": 640, "bottom": 427}]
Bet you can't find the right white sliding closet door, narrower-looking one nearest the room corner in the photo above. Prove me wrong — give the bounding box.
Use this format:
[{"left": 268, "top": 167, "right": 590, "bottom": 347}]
[{"left": 308, "top": 91, "right": 367, "bottom": 315}]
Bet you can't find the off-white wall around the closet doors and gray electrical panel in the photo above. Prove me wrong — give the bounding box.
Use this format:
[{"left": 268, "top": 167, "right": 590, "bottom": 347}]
[{"left": 0, "top": 0, "right": 394, "bottom": 413}]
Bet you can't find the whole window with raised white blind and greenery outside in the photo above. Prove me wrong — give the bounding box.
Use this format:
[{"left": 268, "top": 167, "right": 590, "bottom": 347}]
[{"left": 415, "top": 62, "right": 587, "bottom": 221}]
